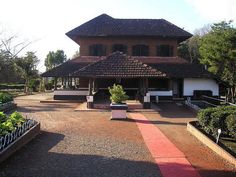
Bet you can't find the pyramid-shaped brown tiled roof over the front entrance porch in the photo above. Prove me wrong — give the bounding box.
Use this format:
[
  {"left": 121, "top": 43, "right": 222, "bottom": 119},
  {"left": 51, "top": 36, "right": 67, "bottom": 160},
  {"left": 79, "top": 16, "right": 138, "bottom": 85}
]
[{"left": 72, "top": 52, "right": 166, "bottom": 78}]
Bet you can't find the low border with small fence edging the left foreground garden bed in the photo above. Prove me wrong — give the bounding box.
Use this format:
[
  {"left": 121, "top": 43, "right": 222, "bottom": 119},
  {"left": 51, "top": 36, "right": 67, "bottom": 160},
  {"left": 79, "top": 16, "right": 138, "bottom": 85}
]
[{"left": 0, "top": 119, "right": 40, "bottom": 163}]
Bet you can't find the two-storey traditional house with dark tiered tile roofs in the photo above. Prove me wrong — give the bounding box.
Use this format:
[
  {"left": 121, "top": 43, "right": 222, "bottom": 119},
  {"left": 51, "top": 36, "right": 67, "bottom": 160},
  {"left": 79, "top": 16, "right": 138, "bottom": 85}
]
[{"left": 42, "top": 14, "right": 219, "bottom": 107}]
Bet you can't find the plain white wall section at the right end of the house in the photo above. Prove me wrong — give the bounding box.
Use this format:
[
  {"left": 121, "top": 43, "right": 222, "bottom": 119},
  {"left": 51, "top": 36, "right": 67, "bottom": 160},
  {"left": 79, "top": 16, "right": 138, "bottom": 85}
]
[{"left": 183, "top": 78, "right": 219, "bottom": 96}]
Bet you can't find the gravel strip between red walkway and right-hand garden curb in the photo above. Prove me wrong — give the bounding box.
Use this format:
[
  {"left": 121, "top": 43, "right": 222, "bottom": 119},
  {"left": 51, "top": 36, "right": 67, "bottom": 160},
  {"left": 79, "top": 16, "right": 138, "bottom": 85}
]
[{"left": 143, "top": 103, "right": 236, "bottom": 177}]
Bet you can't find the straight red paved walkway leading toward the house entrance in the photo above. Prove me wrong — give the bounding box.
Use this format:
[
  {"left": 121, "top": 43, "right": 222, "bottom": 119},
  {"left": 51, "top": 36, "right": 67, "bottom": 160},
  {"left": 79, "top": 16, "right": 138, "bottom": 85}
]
[{"left": 130, "top": 113, "right": 200, "bottom": 177}]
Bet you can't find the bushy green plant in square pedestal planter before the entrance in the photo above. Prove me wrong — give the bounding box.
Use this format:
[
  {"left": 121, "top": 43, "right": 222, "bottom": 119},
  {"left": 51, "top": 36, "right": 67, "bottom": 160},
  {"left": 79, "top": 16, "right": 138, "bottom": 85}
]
[{"left": 108, "top": 84, "right": 129, "bottom": 119}]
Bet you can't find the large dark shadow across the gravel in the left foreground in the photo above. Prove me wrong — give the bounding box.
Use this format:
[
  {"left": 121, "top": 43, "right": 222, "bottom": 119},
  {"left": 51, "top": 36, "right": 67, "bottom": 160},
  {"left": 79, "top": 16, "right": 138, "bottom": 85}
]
[{"left": 0, "top": 132, "right": 160, "bottom": 177}]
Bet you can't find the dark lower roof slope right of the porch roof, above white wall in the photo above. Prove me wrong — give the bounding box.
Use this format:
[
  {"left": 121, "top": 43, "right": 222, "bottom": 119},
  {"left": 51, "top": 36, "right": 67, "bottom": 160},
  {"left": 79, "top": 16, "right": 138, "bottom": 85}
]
[{"left": 150, "top": 63, "right": 214, "bottom": 78}]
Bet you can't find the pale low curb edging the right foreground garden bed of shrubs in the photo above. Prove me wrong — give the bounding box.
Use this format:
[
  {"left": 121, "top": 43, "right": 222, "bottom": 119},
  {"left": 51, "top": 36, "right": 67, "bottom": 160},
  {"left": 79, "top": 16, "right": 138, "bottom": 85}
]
[{"left": 187, "top": 121, "right": 236, "bottom": 167}]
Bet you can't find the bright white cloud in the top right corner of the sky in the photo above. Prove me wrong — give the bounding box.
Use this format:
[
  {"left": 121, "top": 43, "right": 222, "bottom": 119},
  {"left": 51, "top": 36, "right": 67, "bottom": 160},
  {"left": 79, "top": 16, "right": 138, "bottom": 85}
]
[{"left": 185, "top": 0, "right": 236, "bottom": 23}]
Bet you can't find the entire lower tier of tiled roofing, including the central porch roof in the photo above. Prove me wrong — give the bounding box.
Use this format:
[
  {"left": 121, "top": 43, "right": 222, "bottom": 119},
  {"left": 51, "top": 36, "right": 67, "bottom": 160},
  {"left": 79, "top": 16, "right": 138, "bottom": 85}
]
[{"left": 41, "top": 55, "right": 213, "bottom": 78}]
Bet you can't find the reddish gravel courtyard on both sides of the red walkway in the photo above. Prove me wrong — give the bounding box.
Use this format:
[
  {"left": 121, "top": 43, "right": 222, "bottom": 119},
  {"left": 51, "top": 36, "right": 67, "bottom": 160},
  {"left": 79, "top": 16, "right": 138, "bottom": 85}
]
[{"left": 0, "top": 93, "right": 236, "bottom": 177}]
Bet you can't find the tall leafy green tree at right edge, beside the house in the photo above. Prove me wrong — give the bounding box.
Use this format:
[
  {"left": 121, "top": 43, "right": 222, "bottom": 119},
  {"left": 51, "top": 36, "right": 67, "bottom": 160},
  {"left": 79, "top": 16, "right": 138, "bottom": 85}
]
[{"left": 199, "top": 21, "right": 236, "bottom": 102}]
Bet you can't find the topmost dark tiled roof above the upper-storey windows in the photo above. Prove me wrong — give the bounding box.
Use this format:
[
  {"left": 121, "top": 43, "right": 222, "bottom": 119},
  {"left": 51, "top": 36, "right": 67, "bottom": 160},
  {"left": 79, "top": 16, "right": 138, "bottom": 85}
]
[{"left": 66, "top": 14, "right": 192, "bottom": 41}]
